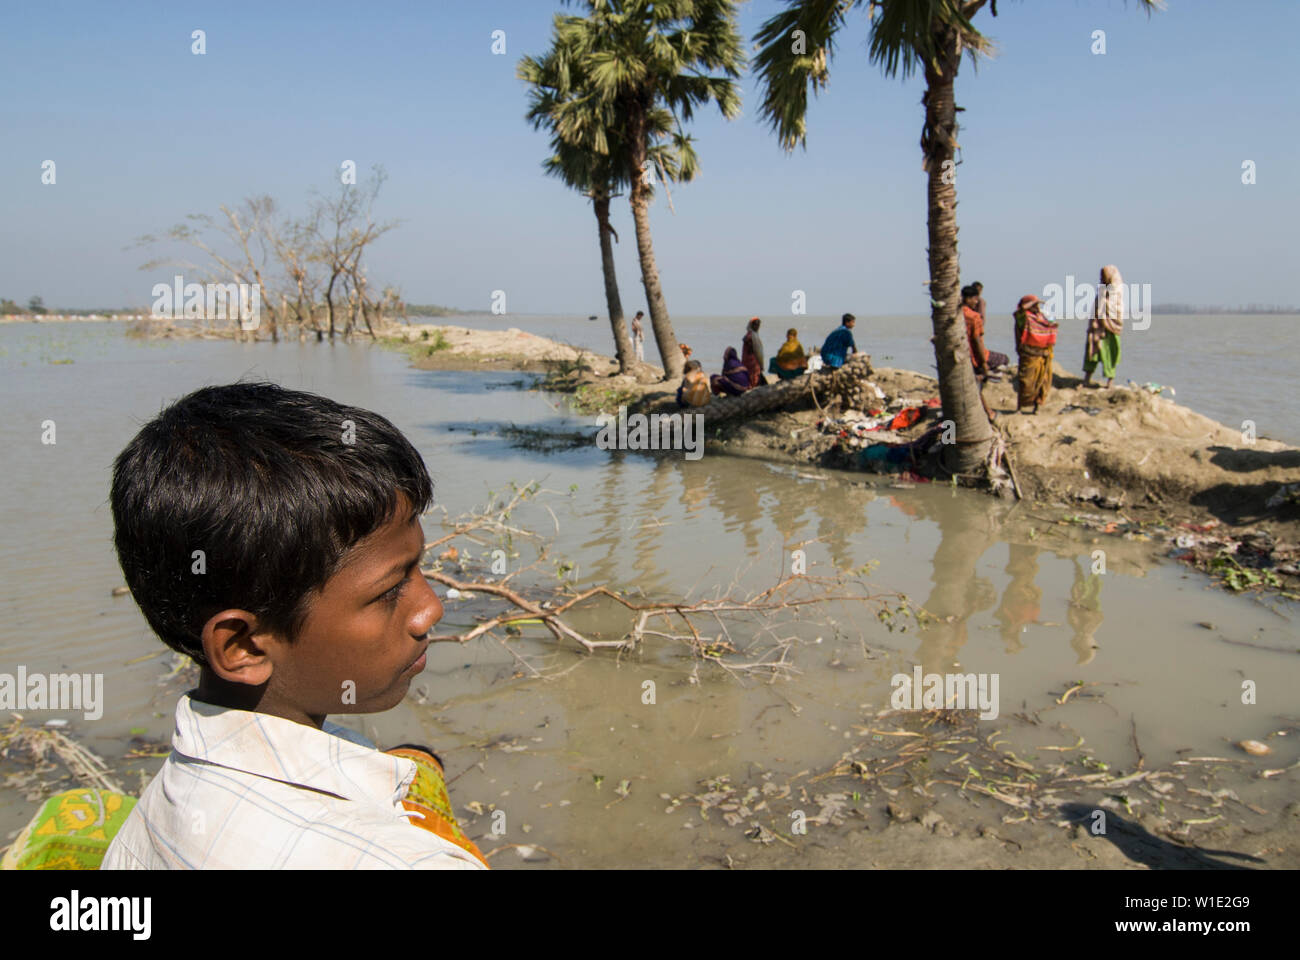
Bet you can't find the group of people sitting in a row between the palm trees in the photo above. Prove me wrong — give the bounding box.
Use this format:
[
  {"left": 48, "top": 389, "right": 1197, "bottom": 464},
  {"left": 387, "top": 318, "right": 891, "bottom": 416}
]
[{"left": 677, "top": 313, "right": 858, "bottom": 407}]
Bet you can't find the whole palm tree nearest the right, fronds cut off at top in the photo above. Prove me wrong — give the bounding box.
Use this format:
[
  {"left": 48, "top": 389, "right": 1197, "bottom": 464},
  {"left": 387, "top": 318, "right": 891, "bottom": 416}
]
[{"left": 754, "top": 0, "right": 1162, "bottom": 473}]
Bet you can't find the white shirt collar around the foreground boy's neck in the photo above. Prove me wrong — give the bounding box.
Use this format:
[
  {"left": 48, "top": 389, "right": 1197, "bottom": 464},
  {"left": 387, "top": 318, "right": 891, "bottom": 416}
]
[{"left": 172, "top": 695, "right": 415, "bottom": 805}]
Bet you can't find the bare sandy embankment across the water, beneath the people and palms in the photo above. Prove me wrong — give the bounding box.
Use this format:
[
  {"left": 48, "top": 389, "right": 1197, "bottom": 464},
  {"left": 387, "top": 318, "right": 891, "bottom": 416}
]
[{"left": 403, "top": 317, "right": 1300, "bottom": 561}]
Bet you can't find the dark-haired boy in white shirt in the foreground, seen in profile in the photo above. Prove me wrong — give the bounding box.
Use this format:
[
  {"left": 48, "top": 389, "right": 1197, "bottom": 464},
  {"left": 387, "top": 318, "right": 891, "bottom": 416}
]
[{"left": 103, "top": 382, "right": 486, "bottom": 869}]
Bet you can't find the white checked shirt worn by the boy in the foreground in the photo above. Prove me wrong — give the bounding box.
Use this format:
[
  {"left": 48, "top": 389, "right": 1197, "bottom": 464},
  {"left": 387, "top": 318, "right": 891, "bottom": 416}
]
[{"left": 101, "top": 696, "right": 484, "bottom": 870}]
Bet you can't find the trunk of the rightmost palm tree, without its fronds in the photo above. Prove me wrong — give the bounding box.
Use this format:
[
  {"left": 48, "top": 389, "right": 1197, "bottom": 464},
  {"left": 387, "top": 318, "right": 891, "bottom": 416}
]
[{"left": 922, "top": 25, "right": 993, "bottom": 473}]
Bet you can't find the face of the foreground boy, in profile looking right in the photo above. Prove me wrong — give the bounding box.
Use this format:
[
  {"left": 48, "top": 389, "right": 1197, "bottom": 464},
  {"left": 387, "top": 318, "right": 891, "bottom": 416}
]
[{"left": 224, "top": 496, "right": 442, "bottom": 726}]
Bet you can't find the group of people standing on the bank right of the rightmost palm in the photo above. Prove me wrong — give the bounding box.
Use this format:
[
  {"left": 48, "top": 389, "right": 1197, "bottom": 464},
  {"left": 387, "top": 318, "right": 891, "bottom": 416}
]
[{"left": 962, "top": 264, "right": 1125, "bottom": 414}]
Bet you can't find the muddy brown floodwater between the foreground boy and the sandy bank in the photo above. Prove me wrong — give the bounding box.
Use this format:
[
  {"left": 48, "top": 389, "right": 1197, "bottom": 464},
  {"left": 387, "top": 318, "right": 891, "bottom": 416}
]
[{"left": 0, "top": 317, "right": 1300, "bottom": 866}]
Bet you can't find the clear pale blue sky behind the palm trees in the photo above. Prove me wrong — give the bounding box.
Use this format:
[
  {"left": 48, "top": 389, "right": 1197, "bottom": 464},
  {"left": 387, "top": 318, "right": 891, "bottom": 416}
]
[{"left": 0, "top": 0, "right": 1300, "bottom": 315}]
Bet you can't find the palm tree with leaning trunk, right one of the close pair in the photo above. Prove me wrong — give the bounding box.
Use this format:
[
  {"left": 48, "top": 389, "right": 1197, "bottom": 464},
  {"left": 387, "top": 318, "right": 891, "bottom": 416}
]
[{"left": 540, "top": 0, "right": 745, "bottom": 380}]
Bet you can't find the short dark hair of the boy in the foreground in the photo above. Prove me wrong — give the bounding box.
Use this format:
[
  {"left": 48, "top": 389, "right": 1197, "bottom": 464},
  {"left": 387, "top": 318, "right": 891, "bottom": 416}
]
[{"left": 111, "top": 382, "right": 433, "bottom": 663}]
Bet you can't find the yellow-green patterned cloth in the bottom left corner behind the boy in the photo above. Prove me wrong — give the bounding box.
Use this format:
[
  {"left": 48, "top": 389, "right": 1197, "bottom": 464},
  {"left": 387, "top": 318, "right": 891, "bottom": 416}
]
[{"left": 0, "top": 787, "right": 135, "bottom": 870}]
